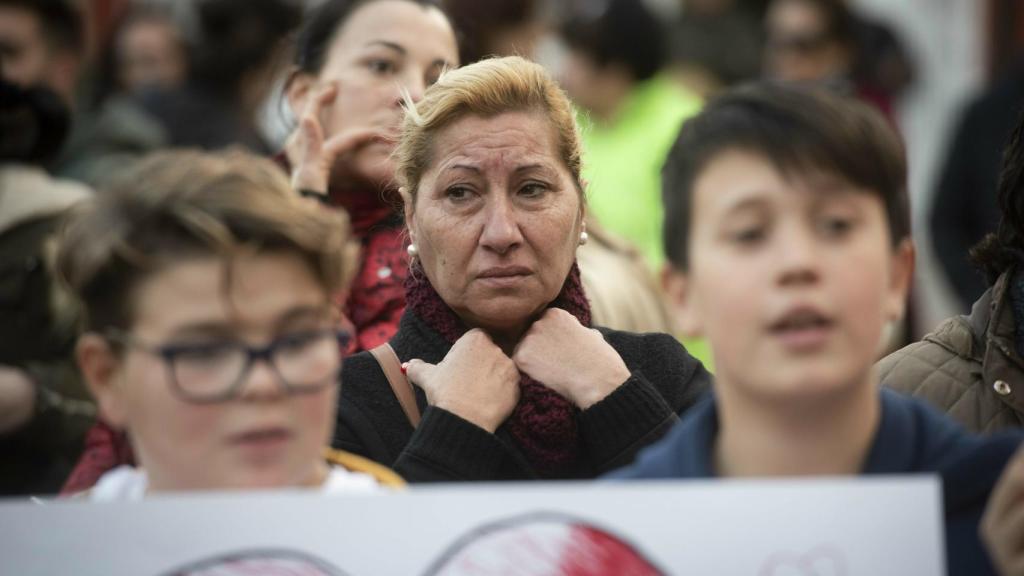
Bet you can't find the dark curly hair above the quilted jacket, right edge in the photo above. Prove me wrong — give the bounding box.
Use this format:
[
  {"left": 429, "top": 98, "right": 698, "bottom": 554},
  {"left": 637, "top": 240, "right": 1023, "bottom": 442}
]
[{"left": 970, "top": 113, "right": 1024, "bottom": 284}]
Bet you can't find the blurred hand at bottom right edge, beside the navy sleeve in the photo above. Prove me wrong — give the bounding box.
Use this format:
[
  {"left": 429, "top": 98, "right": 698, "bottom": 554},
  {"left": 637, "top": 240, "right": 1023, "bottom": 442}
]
[{"left": 980, "top": 440, "right": 1024, "bottom": 576}]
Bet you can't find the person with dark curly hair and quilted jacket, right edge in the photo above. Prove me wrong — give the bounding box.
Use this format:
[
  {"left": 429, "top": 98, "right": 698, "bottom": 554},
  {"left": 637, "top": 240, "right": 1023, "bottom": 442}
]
[{"left": 878, "top": 116, "right": 1024, "bottom": 433}]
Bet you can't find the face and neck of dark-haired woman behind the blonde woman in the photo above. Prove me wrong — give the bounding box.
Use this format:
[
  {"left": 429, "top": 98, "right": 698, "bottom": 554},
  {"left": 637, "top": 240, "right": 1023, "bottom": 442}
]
[{"left": 317, "top": 0, "right": 459, "bottom": 184}]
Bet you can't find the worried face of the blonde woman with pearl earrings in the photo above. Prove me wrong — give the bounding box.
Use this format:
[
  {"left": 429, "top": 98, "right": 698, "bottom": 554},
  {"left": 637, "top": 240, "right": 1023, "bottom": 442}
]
[{"left": 406, "top": 112, "right": 583, "bottom": 339}]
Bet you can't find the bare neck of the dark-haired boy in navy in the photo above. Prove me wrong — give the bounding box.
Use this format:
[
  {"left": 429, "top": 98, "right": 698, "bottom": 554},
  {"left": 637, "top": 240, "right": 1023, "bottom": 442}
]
[{"left": 714, "top": 373, "right": 881, "bottom": 477}]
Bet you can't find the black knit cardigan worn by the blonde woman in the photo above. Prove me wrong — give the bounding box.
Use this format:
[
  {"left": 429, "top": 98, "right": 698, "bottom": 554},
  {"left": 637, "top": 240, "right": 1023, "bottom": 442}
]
[{"left": 333, "top": 310, "right": 711, "bottom": 482}]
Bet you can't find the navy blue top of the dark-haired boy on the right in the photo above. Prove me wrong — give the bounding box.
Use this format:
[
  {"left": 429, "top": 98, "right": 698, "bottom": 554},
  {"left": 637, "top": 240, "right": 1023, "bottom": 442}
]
[{"left": 609, "top": 389, "right": 1024, "bottom": 576}]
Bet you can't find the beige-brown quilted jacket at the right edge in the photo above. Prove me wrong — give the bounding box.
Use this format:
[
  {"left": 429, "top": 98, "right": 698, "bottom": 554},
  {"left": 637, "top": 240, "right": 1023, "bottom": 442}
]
[{"left": 876, "top": 273, "right": 1024, "bottom": 433}]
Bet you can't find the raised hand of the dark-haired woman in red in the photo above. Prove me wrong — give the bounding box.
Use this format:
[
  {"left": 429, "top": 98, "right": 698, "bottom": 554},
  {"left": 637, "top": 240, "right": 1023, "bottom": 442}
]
[{"left": 285, "top": 83, "right": 388, "bottom": 195}]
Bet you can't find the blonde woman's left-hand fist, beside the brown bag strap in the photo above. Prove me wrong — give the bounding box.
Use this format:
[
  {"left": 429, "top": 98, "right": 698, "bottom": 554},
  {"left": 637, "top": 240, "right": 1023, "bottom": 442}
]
[{"left": 406, "top": 329, "right": 519, "bottom": 434}]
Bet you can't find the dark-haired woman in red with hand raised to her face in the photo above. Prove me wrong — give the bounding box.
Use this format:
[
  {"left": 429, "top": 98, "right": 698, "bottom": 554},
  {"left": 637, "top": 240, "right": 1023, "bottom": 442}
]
[{"left": 287, "top": 0, "right": 459, "bottom": 349}]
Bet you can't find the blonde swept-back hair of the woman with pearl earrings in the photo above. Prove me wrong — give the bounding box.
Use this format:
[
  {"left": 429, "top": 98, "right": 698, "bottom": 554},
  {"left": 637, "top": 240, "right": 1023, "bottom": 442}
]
[{"left": 394, "top": 56, "right": 583, "bottom": 204}]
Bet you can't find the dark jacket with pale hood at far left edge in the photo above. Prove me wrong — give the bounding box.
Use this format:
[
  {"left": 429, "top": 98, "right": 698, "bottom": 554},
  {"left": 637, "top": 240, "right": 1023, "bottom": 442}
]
[{"left": 0, "top": 163, "right": 95, "bottom": 496}]
